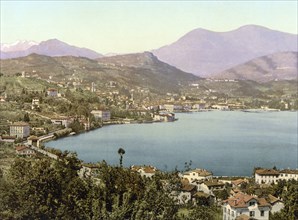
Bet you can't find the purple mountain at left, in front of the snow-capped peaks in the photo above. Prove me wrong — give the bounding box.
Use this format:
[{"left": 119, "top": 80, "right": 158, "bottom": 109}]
[{"left": 1, "top": 39, "right": 102, "bottom": 59}]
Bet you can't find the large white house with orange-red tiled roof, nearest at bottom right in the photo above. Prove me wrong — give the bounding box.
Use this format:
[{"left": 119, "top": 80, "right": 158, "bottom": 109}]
[{"left": 222, "top": 193, "right": 270, "bottom": 220}]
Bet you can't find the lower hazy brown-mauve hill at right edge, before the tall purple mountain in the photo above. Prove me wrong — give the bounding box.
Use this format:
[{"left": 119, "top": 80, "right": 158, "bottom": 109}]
[{"left": 214, "top": 52, "right": 298, "bottom": 82}]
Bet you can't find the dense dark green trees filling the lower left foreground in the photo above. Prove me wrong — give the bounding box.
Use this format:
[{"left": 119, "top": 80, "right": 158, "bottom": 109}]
[{"left": 0, "top": 152, "right": 183, "bottom": 219}]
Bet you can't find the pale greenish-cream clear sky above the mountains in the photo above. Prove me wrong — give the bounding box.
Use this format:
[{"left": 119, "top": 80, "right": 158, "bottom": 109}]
[{"left": 0, "top": 0, "right": 298, "bottom": 54}]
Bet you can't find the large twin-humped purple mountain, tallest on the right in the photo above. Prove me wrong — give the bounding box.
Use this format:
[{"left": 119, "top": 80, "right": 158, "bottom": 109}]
[{"left": 152, "top": 25, "right": 297, "bottom": 76}]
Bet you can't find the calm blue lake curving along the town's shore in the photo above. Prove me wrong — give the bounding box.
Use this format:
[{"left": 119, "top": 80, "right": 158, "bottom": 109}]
[{"left": 46, "top": 111, "right": 298, "bottom": 176}]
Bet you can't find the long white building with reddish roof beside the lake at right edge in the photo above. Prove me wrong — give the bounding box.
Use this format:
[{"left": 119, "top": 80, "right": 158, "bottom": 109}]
[{"left": 255, "top": 168, "right": 298, "bottom": 184}]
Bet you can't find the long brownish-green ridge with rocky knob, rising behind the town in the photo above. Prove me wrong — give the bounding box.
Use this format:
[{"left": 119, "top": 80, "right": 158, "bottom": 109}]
[{"left": 0, "top": 52, "right": 199, "bottom": 93}]
